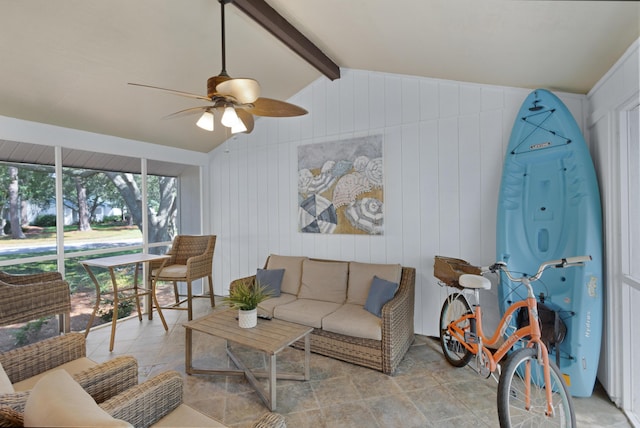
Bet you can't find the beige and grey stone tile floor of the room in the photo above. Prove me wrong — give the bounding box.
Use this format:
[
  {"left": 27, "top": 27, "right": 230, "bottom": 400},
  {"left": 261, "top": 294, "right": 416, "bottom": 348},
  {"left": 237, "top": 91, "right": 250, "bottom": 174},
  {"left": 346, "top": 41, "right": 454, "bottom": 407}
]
[{"left": 87, "top": 299, "right": 631, "bottom": 428}]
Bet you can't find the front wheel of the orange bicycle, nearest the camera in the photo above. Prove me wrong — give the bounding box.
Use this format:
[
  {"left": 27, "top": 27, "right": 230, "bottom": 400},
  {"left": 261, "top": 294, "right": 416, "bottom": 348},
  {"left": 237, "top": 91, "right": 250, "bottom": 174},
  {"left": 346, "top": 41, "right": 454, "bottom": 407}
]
[{"left": 498, "top": 348, "right": 576, "bottom": 428}]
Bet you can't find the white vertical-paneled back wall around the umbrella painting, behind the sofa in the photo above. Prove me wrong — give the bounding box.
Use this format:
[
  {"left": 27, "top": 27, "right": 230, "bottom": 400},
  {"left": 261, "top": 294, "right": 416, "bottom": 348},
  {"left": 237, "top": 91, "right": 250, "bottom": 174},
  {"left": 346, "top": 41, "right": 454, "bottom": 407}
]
[{"left": 209, "top": 69, "right": 587, "bottom": 335}]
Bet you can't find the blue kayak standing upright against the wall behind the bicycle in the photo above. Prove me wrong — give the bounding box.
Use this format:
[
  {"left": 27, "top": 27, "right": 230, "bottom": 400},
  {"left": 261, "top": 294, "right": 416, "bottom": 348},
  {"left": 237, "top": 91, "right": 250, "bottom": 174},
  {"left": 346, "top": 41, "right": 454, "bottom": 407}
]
[{"left": 496, "top": 89, "right": 604, "bottom": 397}]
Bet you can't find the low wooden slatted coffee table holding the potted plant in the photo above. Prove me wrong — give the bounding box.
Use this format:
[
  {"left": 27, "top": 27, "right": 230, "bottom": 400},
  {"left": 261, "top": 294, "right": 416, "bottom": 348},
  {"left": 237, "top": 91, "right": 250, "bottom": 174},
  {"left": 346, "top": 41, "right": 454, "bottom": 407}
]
[{"left": 184, "top": 309, "right": 313, "bottom": 411}]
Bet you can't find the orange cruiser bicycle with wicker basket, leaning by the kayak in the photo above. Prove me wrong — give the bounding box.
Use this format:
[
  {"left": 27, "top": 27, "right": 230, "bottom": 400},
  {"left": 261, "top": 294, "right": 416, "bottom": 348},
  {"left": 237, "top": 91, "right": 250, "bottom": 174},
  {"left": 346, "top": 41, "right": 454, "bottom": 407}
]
[{"left": 434, "top": 256, "right": 591, "bottom": 426}]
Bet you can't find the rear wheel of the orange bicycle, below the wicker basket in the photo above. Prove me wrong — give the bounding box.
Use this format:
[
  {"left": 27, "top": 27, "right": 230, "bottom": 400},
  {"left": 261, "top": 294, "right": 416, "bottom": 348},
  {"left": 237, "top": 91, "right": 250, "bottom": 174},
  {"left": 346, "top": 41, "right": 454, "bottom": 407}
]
[{"left": 440, "top": 293, "right": 476, "bottom": 367}]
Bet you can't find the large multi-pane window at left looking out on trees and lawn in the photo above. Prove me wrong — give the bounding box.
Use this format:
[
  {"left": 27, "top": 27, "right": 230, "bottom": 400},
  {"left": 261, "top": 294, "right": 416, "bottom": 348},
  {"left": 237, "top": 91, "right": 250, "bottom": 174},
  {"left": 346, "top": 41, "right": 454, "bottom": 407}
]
[{"left": 0, "top": 140, "right": 190, "bottom": 350}]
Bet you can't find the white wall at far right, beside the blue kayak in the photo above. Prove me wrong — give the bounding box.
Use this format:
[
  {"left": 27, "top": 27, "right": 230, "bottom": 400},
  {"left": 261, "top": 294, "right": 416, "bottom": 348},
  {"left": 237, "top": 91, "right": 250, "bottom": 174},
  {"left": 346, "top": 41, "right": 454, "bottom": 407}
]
[{"left": 588, "top": 40, "right": 640, "bottom": 423}]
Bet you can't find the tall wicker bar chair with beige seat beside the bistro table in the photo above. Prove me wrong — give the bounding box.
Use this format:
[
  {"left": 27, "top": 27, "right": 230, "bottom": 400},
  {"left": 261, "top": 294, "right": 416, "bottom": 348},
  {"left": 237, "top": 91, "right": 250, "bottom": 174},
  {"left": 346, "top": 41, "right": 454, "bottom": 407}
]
[{"left": 151, "top": 235, "right": 216, "bottom": 321}]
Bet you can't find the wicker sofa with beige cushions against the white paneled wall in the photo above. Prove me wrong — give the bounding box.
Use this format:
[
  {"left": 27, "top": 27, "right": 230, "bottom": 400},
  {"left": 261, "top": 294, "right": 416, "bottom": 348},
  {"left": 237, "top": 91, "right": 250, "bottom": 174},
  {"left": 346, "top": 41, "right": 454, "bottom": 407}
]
[{"left": 230, "top": 254, "right": 415, "bottom": 374}]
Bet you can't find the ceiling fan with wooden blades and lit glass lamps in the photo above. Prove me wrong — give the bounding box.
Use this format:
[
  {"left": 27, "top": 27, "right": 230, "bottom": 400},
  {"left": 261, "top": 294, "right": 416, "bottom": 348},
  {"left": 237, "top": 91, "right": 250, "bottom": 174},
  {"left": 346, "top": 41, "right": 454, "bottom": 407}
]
[{"left": 129, "top": 0, "right": 308, "bottom": 134}]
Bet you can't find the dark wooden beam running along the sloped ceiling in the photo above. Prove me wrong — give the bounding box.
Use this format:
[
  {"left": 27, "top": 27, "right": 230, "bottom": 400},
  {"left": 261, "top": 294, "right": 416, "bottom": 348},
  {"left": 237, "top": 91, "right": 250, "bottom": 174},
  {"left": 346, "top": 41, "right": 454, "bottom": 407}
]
[{"left": 230, "top": 0, "right": 340, "bottom": 80}]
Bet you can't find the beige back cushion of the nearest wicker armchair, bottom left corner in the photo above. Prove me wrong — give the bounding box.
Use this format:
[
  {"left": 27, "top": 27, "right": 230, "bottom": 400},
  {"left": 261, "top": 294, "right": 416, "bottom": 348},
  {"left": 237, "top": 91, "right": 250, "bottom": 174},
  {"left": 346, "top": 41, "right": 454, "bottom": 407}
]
[{"left": 24, "top": 370, "right": 132, "bottom": 427}]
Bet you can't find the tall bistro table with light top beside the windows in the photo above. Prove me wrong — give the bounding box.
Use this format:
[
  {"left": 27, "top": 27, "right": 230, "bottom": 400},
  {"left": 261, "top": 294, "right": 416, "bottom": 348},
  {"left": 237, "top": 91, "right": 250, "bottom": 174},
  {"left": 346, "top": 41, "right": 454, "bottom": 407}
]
[{"left": 80, "top": 254, "right": 171, "bottom": 351}]
